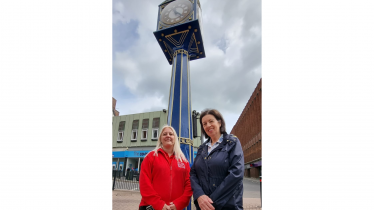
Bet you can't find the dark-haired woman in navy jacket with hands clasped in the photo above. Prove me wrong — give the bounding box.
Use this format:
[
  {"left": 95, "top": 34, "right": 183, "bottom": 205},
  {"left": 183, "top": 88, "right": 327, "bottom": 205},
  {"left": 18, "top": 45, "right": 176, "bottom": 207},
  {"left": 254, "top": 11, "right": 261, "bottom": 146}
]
[{"left": 190, "top": 109, "right": 244, "bottom": 210}]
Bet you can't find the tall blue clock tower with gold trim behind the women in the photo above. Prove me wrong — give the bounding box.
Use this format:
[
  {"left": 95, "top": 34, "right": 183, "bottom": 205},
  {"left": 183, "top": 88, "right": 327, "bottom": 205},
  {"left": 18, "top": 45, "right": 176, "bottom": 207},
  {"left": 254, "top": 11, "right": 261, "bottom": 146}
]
[{"left": 153, "top": 0, "right": 205, "bottom": 210}]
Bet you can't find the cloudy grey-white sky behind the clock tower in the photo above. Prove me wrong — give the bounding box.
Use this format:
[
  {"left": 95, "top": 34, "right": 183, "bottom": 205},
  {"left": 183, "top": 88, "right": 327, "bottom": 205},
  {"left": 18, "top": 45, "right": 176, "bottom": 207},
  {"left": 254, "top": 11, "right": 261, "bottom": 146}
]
[{"left": 112, "top": 0, "right": 262, "bottom": 133}]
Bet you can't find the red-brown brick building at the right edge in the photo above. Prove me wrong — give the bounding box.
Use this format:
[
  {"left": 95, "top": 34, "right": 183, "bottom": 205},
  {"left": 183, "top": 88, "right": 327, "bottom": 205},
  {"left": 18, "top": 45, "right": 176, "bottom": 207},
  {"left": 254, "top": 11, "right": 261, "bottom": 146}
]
[{"left": 231, "top": 78, "right": 262, "bottom": 177}]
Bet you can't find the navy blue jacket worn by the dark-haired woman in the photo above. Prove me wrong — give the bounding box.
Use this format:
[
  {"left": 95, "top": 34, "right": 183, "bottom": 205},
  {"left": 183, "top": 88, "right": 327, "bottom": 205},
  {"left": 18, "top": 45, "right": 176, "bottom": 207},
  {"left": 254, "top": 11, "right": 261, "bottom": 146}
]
[{"left": 190, "top": 134, "right": 244, "bottom": 210}]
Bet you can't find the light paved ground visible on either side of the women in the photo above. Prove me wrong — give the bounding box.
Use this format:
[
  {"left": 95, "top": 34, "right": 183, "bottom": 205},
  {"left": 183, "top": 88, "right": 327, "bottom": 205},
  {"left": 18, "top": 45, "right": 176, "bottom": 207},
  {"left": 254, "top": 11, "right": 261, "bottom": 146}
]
[{"left": 112, "top": 190, "right": 261, "bottom": 210}]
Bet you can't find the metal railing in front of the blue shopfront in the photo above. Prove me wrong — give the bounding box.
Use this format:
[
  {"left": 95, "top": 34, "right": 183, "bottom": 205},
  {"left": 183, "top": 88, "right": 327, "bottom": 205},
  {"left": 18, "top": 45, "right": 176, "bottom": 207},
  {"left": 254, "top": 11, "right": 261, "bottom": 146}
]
[{"left": 112, "top": 170, "right": 140, "bottom": 191}]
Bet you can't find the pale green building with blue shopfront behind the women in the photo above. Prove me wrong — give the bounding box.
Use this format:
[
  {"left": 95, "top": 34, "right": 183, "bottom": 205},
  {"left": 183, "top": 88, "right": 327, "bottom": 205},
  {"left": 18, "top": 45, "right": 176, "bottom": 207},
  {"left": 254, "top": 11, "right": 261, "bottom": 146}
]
[{"left": 112, "top": 109, "right": 201, "bottom": 174}]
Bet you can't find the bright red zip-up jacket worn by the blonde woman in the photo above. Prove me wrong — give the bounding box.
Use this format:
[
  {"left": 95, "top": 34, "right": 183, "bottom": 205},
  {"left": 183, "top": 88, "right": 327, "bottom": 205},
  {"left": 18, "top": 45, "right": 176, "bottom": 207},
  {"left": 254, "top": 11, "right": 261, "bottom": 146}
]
[{"left": 139, "top": 149, "right": 192, "bottom": 210}]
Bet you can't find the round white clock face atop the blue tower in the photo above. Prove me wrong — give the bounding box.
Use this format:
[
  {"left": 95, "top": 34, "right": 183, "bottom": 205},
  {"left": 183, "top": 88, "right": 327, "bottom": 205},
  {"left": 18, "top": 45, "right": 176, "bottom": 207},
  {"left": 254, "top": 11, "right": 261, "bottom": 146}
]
[{"left": 161, "top": 0, "right": 192, "bottom": 25}]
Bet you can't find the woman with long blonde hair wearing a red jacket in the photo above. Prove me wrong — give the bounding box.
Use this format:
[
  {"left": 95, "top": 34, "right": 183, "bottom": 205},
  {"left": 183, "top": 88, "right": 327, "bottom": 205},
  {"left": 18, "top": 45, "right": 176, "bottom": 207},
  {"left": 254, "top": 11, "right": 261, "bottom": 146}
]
[{"left": 139, "top": 125, "right": 192, "bottom": 210}]
